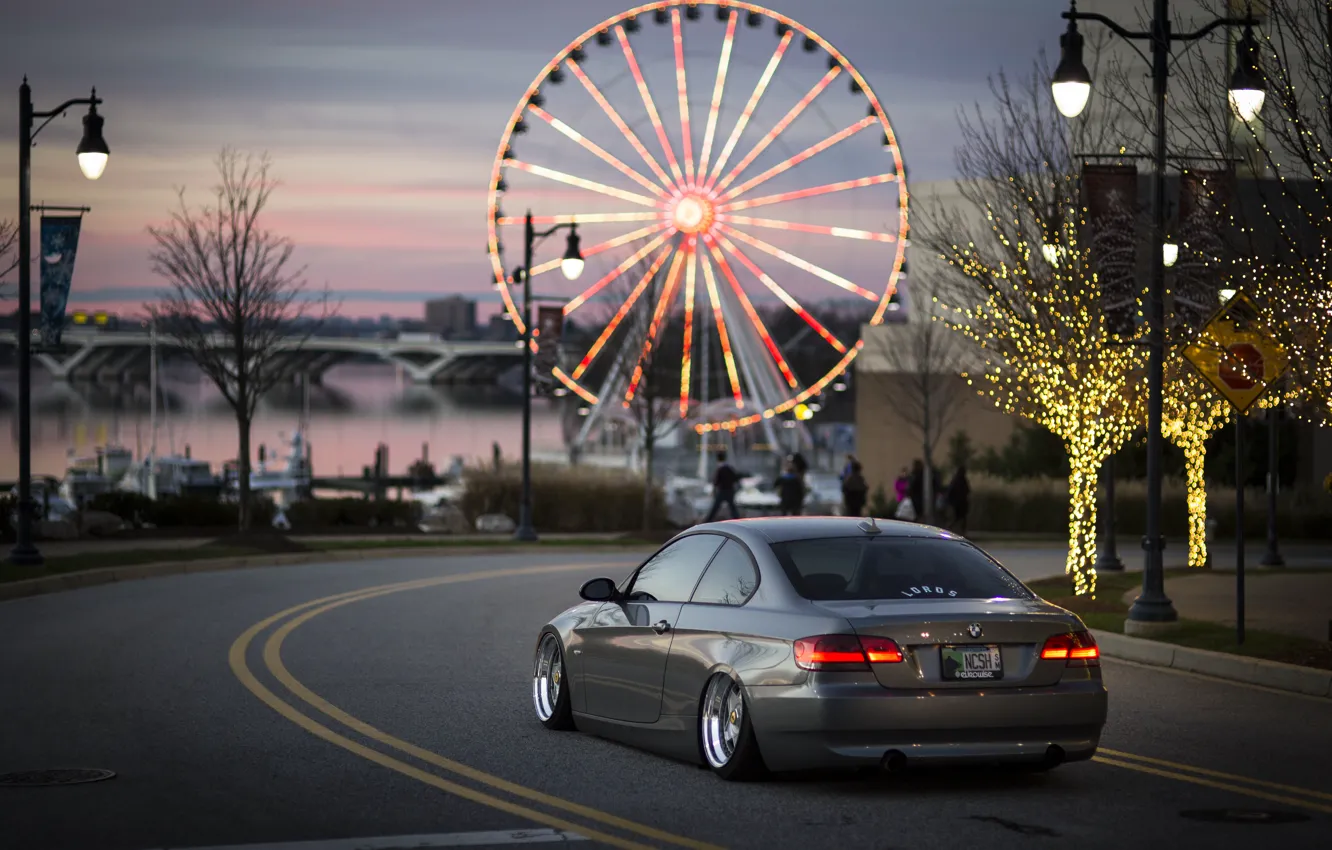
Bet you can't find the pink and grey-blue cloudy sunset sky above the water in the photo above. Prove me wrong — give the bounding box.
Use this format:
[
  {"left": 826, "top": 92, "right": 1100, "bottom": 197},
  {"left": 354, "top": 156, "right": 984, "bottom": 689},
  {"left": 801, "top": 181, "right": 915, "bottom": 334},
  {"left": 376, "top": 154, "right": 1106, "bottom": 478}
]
[{"left": 0, "top": 0, "right": 1066, "bottom": 316}]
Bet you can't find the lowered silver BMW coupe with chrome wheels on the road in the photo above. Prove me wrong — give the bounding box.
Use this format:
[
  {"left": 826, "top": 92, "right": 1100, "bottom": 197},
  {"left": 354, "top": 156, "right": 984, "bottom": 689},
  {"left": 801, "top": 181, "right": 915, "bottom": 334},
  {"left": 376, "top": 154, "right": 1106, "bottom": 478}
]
[{"left": 531, "top": 517, "right": 1106, "bottom": 779}]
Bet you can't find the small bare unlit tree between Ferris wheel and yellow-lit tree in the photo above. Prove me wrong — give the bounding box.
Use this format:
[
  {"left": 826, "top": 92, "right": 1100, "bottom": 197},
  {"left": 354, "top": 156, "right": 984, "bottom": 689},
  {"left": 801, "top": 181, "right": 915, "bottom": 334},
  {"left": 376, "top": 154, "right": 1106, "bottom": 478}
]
[{"left": 868, "top": 276, "right": 967, "bottom": 521}]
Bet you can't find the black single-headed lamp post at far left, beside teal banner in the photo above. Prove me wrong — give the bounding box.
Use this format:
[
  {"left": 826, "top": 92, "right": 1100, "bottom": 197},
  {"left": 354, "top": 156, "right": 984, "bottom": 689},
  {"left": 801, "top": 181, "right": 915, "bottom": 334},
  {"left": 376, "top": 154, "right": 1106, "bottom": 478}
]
[{"left": 9, "top": 77, "right": 111, "bottom": 566}]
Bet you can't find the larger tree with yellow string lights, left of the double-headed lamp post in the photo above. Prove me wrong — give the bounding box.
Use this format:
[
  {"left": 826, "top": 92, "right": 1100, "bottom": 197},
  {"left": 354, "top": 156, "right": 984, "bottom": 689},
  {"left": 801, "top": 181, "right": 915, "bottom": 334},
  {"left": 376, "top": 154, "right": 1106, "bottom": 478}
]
[{"left": 915, "top": 64, "right": 1146, "bottom": 594}]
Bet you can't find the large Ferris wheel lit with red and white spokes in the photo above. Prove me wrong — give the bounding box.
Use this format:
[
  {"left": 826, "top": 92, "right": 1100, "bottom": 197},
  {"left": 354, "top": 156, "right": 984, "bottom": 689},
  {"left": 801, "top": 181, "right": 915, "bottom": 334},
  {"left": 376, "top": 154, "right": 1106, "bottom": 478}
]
[{"left": 489, "top": 0, "right": 907, "bottom": 452}]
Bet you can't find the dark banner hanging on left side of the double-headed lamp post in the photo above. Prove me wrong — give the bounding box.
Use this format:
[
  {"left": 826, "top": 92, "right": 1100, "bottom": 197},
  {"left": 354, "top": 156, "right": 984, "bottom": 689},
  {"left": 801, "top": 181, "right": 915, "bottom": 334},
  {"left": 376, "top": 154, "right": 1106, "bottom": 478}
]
[{"left": 1082, "top": 163, "right": 1140, "bottom": 334}]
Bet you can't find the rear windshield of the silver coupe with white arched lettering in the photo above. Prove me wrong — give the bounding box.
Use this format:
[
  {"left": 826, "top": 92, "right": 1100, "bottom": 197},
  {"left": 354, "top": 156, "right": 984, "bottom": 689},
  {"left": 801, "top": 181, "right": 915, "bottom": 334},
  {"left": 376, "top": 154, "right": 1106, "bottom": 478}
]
[{"left": 773, "top": 536, "right": 1034, "bottom": 601}]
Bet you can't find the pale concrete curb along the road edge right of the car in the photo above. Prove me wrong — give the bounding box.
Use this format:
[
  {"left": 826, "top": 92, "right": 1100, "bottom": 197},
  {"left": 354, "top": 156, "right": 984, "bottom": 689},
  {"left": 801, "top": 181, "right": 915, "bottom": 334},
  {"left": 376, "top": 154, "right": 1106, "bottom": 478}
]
[{"left": 1092, "top": 630, "right": 1332, "bottom": 697}]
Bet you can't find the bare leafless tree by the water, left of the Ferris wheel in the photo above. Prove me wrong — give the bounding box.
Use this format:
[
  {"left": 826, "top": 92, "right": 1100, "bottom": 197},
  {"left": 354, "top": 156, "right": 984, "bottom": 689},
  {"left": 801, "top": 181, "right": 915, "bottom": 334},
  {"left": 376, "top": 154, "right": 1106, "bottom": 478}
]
[{"left": 147, "top": 148, "right": 329, "bottom": 532}]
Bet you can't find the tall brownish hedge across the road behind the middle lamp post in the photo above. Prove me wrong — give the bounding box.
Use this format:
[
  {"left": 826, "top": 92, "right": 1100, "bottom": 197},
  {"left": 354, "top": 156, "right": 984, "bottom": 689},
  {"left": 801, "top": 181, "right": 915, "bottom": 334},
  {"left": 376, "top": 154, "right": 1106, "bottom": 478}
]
[{"left": 458, "top": 465, "right": 666, "bottom": 533}]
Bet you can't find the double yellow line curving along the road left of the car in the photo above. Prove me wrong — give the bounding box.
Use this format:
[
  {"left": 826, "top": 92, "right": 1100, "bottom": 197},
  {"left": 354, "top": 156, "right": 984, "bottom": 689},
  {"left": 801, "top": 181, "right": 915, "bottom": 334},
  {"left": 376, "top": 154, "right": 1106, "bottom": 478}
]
[{"left": 229, "top": 564, "right": 722, "bottom": 850}]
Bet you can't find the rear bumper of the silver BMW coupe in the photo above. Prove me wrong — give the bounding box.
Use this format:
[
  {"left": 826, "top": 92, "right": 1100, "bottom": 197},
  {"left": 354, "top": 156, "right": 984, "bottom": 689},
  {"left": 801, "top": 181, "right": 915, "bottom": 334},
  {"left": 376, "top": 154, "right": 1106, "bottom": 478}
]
[{"left": 746, "top": 675, "right": 1107, "bottom": 770}]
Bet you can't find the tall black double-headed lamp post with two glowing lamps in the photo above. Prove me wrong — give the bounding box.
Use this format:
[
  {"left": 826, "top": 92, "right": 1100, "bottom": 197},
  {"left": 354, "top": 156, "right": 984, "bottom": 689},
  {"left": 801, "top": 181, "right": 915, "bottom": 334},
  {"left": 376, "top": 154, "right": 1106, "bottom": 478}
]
[{"left": 1050, "top": 0, "right": 1267, "bottom": 632}]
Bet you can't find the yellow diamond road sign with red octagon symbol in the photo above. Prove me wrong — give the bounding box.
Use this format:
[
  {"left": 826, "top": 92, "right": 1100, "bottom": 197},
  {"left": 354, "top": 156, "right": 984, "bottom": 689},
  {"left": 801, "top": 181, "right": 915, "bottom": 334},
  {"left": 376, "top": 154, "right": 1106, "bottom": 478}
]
[{"left": 1184, "top": 292, "right": 1289, "bottom": 413}]
